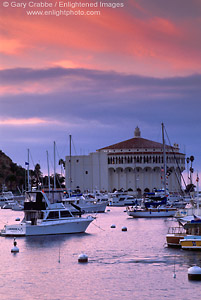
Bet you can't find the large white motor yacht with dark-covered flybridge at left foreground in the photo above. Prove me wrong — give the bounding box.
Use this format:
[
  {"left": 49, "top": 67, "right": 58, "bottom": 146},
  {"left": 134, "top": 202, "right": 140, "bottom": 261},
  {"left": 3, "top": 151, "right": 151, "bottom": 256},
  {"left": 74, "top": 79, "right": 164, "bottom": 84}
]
[{"left": 1, "top": 191, "right": 94, "bottom": 236}]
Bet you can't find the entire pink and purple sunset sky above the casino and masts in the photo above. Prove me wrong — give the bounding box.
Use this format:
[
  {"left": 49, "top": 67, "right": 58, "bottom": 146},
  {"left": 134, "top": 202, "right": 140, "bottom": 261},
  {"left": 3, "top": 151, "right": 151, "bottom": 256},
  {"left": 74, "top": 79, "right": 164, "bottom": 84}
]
[{"left": 0, "top": 0, "right": 201, "bottom": 185}]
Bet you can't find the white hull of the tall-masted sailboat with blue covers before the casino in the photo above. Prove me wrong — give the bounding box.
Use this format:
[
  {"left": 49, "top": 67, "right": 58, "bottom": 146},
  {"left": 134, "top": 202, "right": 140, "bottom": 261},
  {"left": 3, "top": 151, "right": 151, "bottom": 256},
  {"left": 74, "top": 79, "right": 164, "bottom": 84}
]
[{"left": 126, "top": 205, "right": 177, "bottom": 218}]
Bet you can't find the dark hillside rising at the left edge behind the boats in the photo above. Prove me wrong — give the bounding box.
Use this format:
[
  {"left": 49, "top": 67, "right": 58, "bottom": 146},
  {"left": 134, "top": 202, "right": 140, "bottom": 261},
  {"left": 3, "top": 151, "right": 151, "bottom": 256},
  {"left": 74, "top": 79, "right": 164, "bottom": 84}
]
[{"left": 0, "top": 150, "right": 25, "bottom": 191}]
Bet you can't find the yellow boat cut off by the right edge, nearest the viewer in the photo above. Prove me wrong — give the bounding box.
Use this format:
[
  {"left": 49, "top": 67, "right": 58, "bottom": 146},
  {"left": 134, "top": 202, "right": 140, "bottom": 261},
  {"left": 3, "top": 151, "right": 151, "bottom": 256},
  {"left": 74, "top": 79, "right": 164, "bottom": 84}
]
[{"left": 180, "top": 216, "right": 201, "bottom": 250}]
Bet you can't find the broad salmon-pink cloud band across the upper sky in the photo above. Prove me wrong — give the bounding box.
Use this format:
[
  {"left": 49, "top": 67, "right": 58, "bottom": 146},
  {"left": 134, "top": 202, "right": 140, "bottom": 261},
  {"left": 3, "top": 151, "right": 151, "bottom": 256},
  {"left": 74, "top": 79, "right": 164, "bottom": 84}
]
[{"left": 2, "top": 1, "right": 201, "bottom": 76}]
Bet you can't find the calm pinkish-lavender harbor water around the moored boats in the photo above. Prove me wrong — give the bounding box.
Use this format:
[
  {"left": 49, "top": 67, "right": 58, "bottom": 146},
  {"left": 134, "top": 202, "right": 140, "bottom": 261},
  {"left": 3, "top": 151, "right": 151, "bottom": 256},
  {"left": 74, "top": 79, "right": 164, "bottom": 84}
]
[{"left": 0, "top": 208, "right": 201, "bottom": 300}]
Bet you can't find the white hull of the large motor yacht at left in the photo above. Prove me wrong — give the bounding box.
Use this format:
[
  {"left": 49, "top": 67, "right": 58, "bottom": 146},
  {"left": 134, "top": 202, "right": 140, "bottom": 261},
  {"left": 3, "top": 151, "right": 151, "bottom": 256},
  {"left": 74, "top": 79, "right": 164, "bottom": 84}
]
[{"left": 1, "top": 218, "right": 93, "bottom": 236}]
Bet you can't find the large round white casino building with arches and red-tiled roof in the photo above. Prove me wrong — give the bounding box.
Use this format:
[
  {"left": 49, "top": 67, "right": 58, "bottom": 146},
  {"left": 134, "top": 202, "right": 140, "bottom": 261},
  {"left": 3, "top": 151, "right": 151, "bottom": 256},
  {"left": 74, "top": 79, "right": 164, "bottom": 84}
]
[{"left": 66, "top": 127, "right": 185, "bottom": 195}]
